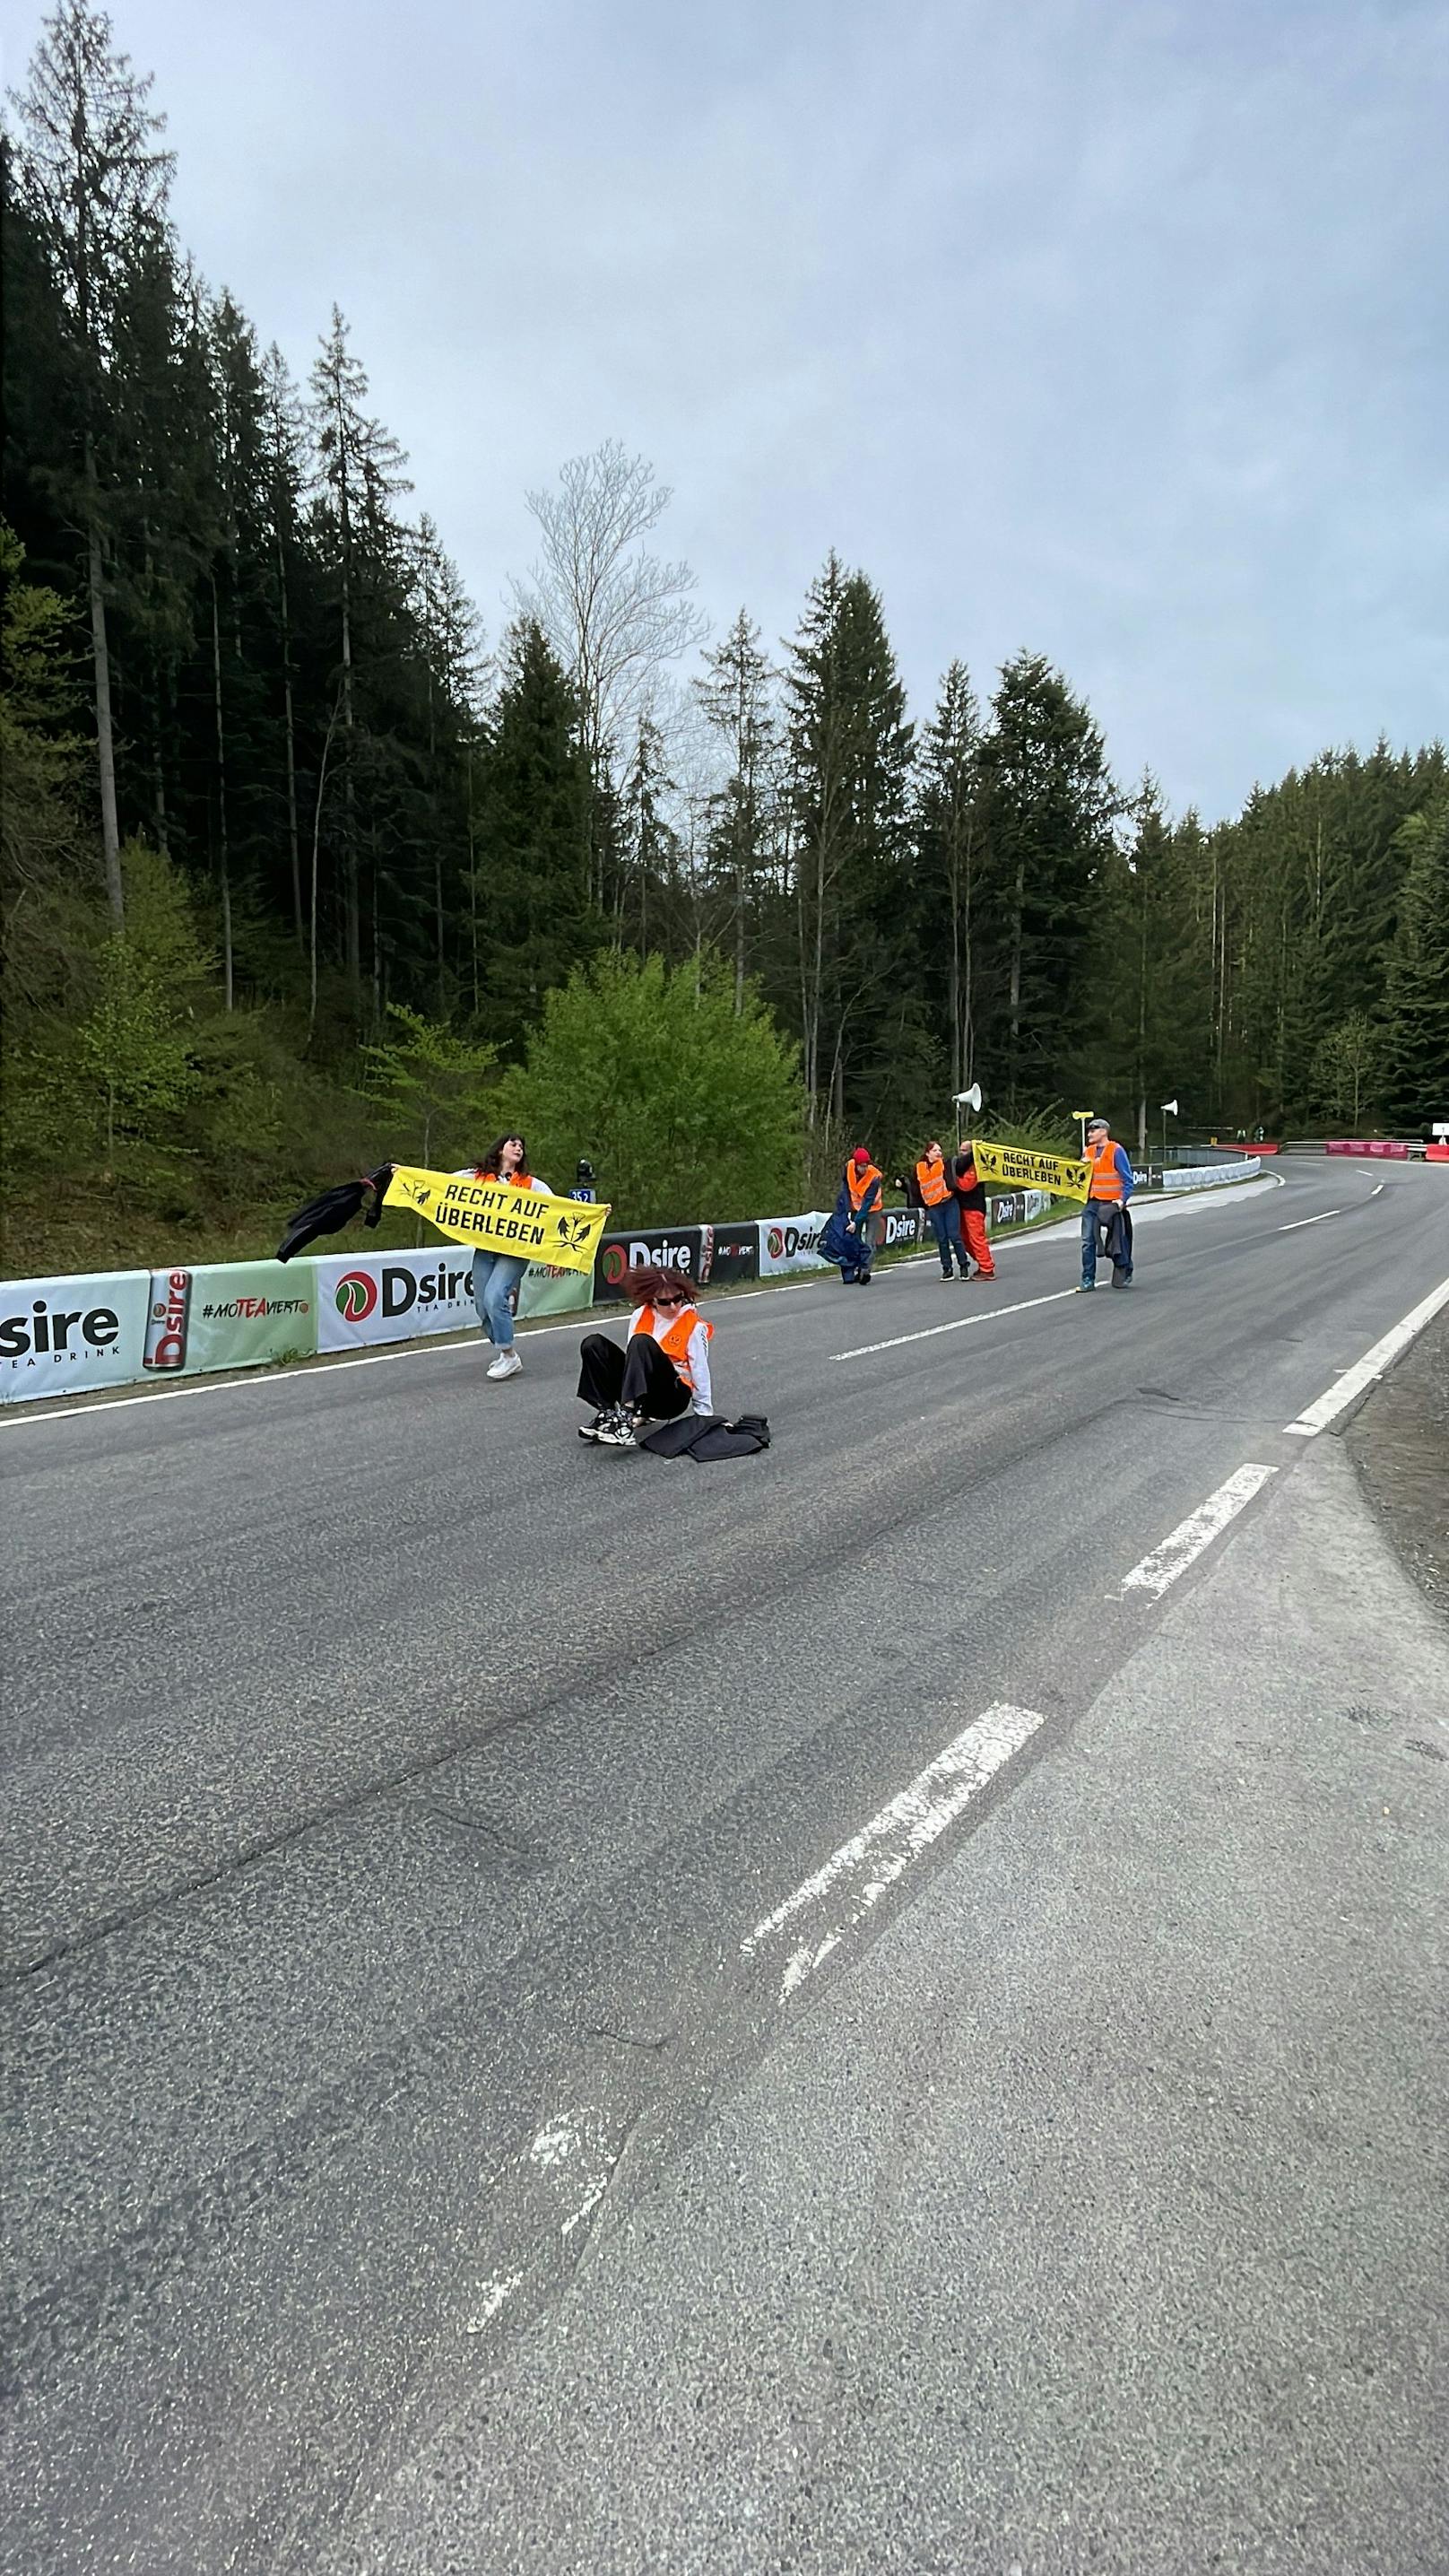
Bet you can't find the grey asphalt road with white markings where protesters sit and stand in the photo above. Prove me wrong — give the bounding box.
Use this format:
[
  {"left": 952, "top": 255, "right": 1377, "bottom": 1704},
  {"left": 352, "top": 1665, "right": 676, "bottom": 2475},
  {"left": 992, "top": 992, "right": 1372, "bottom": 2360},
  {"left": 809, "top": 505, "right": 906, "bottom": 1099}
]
[{"left": 0, "top": 1164, "right": 1449, "bottom": 2576}]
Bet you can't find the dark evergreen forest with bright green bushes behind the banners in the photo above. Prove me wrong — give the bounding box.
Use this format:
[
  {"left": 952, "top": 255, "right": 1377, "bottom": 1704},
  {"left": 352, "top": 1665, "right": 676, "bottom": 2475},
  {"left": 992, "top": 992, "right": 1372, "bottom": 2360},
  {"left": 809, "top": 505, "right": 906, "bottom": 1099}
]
[{"left": 0, "top": 0, "right": 1449, "bottom": 1273}]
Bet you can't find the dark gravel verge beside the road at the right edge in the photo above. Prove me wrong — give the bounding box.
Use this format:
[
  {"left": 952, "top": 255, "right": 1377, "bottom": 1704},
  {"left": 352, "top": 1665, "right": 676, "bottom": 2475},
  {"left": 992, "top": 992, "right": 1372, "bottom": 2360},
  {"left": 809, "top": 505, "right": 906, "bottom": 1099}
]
[{"left": 1343, "top": 1309, "right": 1449, "bottom": 1618}]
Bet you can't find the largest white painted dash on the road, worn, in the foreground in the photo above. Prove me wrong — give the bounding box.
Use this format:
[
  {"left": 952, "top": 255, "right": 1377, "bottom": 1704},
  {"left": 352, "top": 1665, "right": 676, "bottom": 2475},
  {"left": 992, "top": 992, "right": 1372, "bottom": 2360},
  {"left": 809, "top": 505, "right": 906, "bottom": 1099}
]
[{"left": 739, "top": 1701, "right": 1045, "bottom": 2004}]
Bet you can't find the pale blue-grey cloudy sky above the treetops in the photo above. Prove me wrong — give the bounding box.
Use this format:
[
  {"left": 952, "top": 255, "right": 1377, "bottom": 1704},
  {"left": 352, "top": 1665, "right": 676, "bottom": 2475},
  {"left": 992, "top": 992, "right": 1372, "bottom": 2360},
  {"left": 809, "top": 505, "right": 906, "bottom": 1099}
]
[{"left": 0, "top": 0, "right": 1449, "bottom": 816}]
